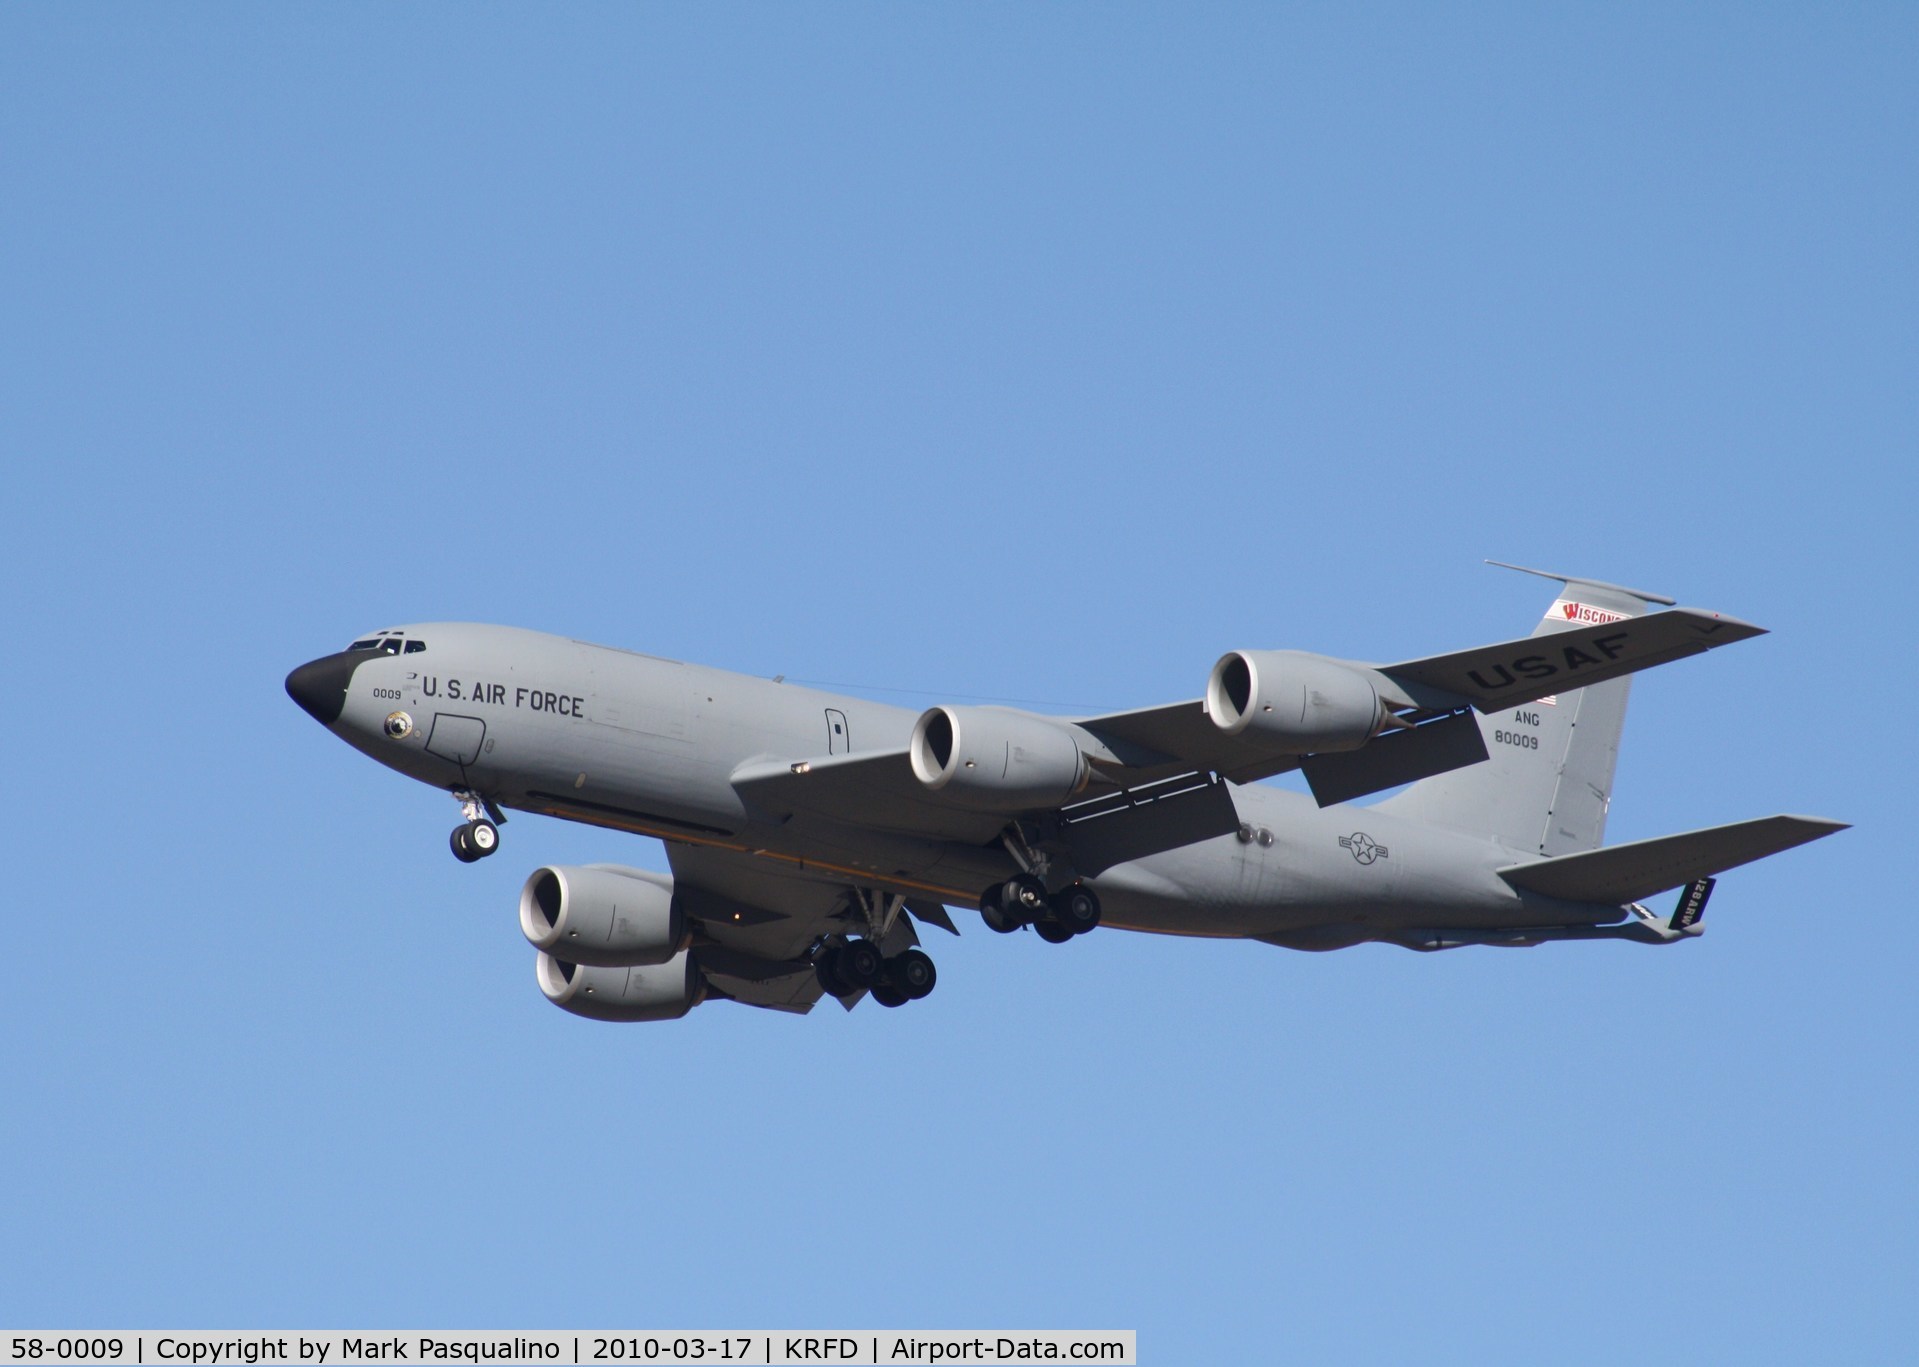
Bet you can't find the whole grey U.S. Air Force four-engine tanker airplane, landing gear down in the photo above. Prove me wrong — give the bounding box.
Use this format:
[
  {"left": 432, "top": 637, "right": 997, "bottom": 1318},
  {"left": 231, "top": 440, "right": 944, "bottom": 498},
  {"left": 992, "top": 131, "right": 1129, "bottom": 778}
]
[{"left": 286, "top": 561, "right": 1846, "bottom": 1021}]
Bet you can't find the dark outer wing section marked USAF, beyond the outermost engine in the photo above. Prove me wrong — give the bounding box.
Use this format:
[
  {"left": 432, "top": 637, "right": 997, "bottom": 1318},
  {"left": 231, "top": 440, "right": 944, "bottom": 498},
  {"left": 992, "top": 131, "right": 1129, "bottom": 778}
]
[{"left": 1380, "top": 607, "right": 1765, "bottom": 712}]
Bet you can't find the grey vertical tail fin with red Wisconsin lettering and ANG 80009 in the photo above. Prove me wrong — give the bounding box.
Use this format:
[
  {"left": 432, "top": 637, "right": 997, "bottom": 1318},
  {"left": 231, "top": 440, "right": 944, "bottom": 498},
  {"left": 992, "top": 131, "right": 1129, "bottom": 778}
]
[{"left": 1380, "top": 561, "right": 1673, "bottom": 854}]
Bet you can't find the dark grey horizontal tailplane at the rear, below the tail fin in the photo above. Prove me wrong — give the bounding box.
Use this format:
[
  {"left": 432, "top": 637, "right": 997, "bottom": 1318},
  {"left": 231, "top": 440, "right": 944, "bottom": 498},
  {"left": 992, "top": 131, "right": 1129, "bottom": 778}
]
[{"left": 1499, "top": 816, "right": 1846, "bottom": 906}]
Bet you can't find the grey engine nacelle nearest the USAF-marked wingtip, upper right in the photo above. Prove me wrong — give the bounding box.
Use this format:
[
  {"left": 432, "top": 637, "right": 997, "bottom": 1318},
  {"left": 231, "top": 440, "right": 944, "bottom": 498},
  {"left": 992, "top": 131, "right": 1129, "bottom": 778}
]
[{"left": 1205, "top": 651, "right": 1386, "bottom": 755}]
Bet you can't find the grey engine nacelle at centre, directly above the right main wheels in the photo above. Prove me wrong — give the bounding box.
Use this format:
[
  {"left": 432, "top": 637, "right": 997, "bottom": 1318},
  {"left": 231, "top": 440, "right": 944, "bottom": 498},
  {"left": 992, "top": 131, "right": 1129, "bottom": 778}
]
[{"left": 908, "top": 707, "right": 1090, "bottom": 812}]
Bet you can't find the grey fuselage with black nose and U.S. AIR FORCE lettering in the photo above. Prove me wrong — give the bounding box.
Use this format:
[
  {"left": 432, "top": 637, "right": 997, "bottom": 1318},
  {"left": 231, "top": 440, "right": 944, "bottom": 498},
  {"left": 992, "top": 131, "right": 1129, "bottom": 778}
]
[{"left": 288, "top": 622, "right": 1625, "bottom": 948}]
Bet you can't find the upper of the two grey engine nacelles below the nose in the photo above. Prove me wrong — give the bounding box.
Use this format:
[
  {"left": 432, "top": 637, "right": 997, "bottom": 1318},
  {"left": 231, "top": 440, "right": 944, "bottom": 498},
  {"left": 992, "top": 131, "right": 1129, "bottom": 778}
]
[{"left": 520, "top": 866, "right": 687, "bottom": 968}]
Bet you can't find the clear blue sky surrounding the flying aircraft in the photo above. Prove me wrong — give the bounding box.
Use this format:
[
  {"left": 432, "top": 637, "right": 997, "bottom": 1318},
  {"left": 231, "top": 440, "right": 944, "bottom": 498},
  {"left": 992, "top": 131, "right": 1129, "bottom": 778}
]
[{"left": 0, "top": 6, "right": 1919, "bottom": 1363}]
